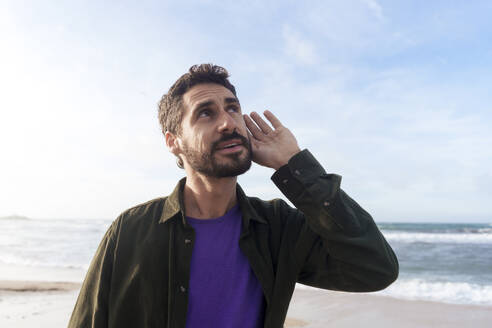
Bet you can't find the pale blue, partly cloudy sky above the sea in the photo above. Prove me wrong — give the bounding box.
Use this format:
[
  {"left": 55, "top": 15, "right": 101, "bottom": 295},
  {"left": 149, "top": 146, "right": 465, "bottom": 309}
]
[{"left": 0, "top": 0, "right": 492, "bottom": 222}]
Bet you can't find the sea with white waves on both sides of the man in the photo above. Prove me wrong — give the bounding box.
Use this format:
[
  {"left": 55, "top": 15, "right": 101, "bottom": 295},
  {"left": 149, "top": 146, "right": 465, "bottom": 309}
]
[{"left": 0, "top": 217, "right": 492, "bottom": 306}]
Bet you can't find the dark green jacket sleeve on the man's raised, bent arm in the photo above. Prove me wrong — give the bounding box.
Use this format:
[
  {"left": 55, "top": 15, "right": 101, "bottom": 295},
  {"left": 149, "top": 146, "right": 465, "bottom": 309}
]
[{"left": 272, "top": 150, "right": 398, "bottom": 292}]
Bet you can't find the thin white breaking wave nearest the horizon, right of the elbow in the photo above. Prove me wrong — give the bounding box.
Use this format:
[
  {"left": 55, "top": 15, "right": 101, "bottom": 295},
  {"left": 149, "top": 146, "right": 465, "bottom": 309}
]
[{"left": 382, "top": 230, "right": 492, "bottom": 244}]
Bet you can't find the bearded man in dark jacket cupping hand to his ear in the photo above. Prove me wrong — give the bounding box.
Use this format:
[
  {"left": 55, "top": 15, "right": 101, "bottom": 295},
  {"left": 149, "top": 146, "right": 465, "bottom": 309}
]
[{"left": 69, "top": 64, "right": 398, "bottom": 328}]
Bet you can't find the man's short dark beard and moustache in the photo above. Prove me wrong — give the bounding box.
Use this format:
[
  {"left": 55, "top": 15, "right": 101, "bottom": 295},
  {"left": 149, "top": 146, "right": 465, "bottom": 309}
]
[{"left": 183, "top": 131, "right": 253, "bottom": 178}]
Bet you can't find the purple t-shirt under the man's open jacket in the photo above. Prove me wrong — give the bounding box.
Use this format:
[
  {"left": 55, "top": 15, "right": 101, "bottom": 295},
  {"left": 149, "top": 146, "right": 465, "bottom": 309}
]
[{"left": 186, "top": 205, "right": 265, "bottom": 328}]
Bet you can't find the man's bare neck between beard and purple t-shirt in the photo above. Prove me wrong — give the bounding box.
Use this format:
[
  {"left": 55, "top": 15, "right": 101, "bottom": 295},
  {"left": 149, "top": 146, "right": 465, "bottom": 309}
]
[{"left": 183, "top": 174, "right": 237, "bottom": 219}]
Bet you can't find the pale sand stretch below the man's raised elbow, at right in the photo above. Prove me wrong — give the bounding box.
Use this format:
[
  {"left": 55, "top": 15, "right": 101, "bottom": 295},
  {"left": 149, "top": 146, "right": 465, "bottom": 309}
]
[{"left": 286, "top": 289, "right": 492, "bottom": 328}]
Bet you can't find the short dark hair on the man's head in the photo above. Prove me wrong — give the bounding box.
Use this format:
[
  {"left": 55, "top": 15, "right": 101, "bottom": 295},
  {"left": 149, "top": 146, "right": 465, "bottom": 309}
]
[{"left": 158, "top": 64, "right": 237, "bottom": 134}]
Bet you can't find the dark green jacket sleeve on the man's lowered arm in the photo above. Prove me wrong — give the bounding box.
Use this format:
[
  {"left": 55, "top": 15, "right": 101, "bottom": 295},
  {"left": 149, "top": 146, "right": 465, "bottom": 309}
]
[{"left": 68, "top": 217, "right": 117, "bottom": 328}]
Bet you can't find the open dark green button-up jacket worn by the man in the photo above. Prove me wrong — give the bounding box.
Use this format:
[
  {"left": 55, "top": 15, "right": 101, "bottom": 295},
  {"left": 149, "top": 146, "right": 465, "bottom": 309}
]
[{"left": 69, "top": 150, "right": 398, "bottom": 328}]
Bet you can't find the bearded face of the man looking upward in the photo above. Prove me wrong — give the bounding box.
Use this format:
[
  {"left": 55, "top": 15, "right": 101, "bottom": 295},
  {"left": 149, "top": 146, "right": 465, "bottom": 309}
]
[{"left": 179, "top": 83, "right": 252, "bottom": 178}]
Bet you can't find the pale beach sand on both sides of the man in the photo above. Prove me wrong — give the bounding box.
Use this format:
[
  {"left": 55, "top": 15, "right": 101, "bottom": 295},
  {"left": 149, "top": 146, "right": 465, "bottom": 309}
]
[{"left": 0, "top": 280, "right": 492, "bottom": 328}]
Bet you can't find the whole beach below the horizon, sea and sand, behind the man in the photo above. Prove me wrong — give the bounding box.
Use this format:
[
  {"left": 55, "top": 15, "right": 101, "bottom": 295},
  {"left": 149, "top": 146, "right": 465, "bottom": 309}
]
[{"left": 0, "top": 219, "right": 492, "bottom": 328}]
